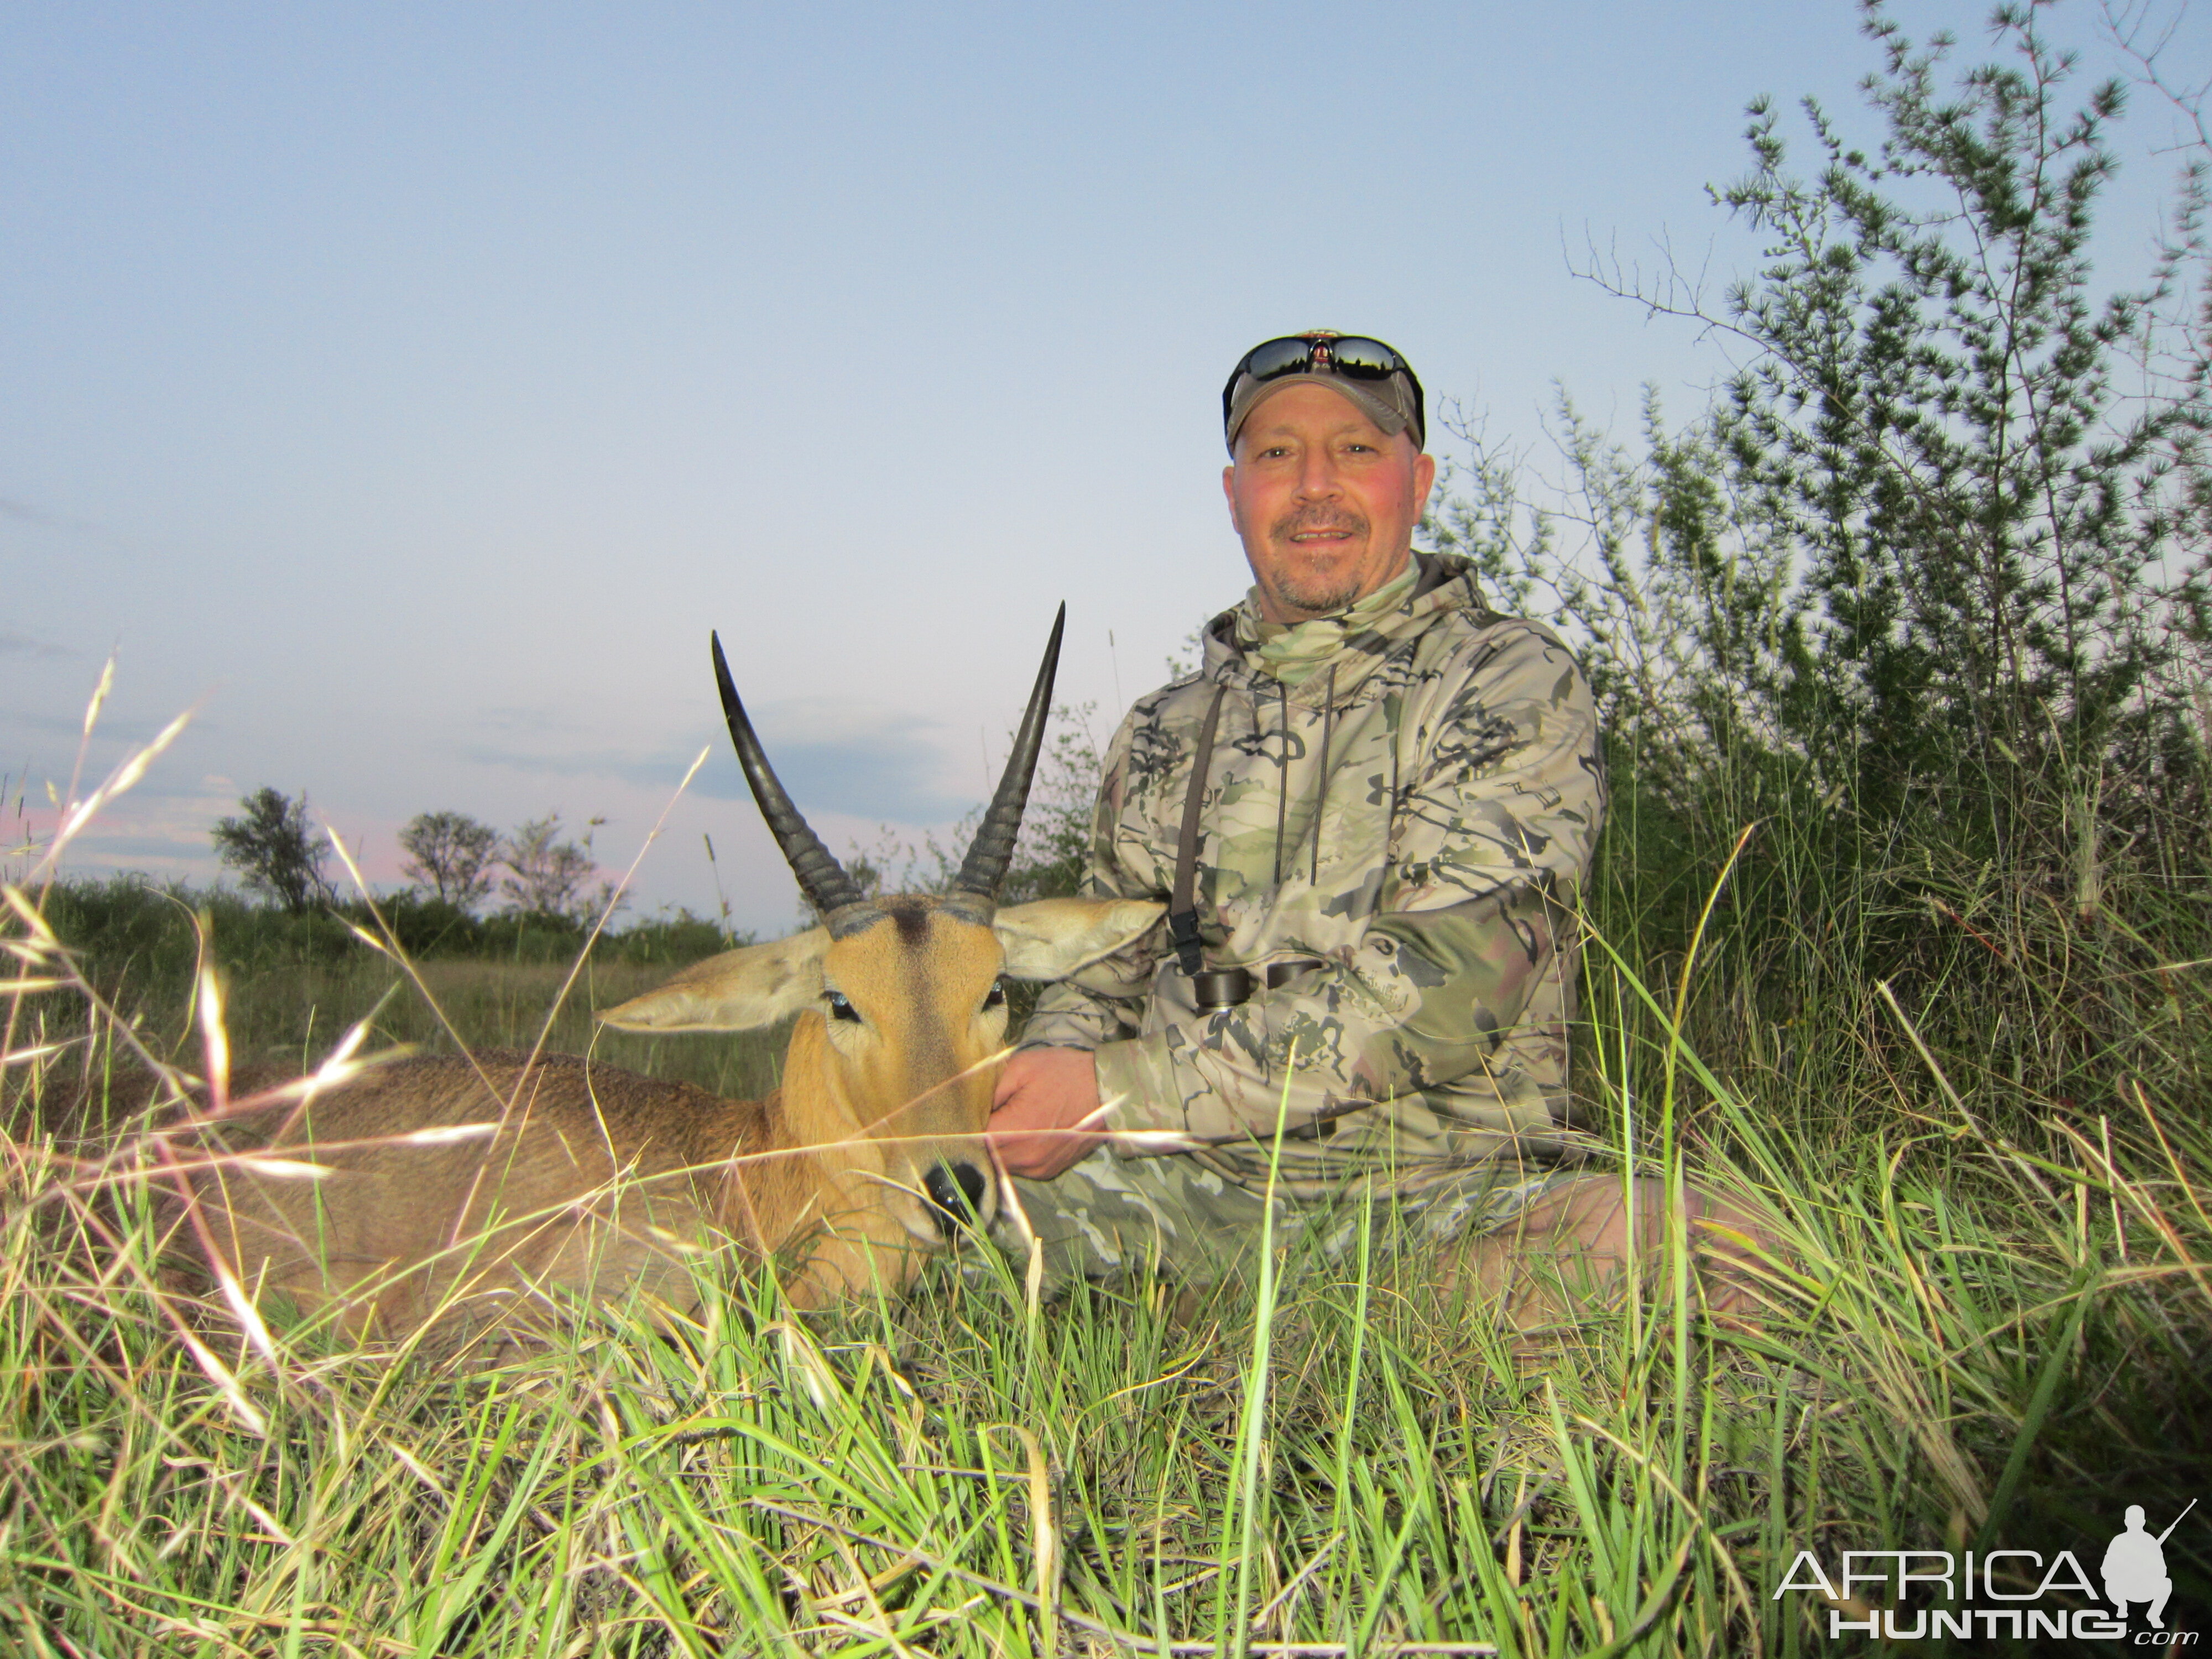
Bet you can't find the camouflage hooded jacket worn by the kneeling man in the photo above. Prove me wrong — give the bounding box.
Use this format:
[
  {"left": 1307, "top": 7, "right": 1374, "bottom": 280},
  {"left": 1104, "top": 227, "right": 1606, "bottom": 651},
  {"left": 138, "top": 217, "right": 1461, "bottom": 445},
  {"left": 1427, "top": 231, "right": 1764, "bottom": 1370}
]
[{"left": 1022, "top": 553, "right": 1606, "bottom": 1194}]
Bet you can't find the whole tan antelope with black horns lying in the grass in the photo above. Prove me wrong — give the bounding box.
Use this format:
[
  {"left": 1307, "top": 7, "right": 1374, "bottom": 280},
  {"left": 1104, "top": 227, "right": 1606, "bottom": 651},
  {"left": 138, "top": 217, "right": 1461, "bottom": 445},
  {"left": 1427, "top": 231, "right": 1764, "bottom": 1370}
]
[{"left": 192, "top": 608, "right": 1161, "bottom": 1334}]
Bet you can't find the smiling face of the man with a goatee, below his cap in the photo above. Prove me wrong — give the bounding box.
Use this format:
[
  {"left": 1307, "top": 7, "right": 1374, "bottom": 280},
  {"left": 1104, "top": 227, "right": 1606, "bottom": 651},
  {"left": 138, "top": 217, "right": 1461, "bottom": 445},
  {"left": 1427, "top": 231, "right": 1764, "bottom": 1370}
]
[{"left": 1221, "top": 380, "right": 1436, "bottom": 622}]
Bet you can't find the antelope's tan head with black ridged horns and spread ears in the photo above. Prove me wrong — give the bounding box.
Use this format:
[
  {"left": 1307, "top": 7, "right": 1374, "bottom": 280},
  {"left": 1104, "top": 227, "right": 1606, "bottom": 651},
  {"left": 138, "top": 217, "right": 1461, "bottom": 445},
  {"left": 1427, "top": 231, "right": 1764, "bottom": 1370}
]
[{"left": 602, "top": 606, "right": 1164, "bottom": 1274}]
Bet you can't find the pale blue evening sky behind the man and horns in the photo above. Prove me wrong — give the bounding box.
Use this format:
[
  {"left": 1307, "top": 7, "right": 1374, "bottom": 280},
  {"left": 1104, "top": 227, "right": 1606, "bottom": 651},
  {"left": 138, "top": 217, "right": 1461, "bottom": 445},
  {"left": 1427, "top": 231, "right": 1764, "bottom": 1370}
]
[{"left": 0, "top": 0, "right": 2212, "bottom": 929}]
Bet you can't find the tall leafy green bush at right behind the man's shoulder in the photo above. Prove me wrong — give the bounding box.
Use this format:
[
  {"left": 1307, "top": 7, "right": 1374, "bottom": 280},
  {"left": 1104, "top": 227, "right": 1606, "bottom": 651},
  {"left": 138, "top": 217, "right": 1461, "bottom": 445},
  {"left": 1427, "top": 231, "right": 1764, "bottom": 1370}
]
[{"left": 1429, "top": 4, "right": 2212, "bottom": 1119}]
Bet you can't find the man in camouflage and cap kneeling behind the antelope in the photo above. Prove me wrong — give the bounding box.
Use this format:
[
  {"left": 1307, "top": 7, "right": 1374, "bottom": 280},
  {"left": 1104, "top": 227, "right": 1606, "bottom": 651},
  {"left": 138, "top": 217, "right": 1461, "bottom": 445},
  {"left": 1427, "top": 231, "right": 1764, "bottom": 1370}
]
[{"left": 991, "top": 332, "right": 1770, "bottom": 1290}]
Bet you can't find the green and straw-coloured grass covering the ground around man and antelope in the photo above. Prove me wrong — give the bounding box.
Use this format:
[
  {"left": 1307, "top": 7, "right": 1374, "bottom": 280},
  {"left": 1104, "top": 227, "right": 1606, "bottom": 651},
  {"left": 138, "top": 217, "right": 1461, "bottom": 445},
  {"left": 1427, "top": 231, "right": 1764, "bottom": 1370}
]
[{"left": 0, "top": 872, "right": 2212, "bottom": 1659}]
